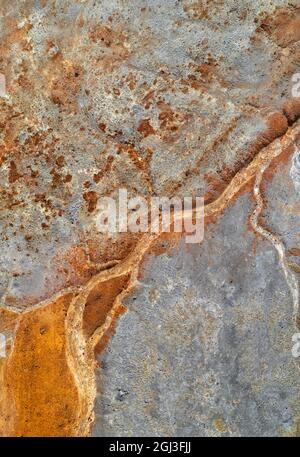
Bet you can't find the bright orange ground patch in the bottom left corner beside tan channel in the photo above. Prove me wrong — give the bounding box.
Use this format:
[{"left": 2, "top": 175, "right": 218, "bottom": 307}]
[{"left": 1, "top": 294, "right": 78, "bottom": 436}]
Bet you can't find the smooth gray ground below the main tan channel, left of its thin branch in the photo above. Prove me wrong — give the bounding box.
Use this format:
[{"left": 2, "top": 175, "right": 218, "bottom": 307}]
[{"left": 93, "top": 191, "right": 300, "bottom": 436}]
